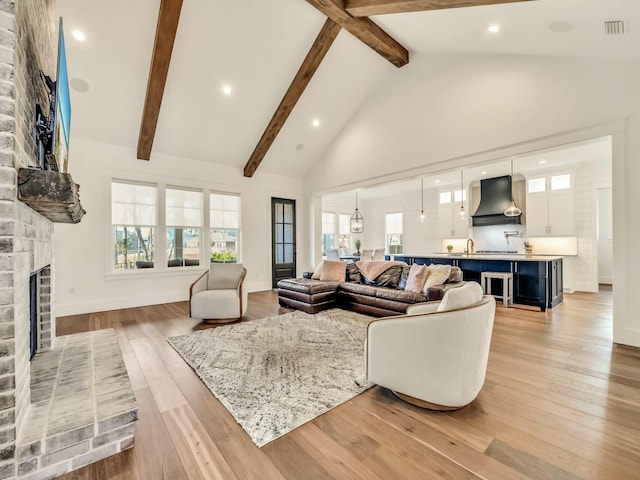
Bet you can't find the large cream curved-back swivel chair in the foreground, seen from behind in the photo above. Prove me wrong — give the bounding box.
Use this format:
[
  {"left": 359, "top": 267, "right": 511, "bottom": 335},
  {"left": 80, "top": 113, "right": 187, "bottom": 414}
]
[{"left": 365, "top": 282, "right": 496, "bottom": 410}]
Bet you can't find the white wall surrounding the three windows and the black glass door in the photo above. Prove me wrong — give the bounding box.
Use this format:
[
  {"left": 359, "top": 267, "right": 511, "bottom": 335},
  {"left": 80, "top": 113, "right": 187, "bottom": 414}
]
[{"left": 54, "top": 139, "right": 307, "bottom": 316}]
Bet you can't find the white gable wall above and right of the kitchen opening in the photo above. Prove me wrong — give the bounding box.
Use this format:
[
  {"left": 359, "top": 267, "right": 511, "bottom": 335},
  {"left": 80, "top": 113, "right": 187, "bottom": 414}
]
[{"left": 305, "top": 54, "right": 640, "bottom": 346}]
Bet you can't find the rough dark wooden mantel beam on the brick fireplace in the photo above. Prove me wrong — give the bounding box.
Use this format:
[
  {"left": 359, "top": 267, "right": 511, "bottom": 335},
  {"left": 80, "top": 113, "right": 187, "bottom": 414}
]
[{"left": 18, "top": 168, "right": 87, "bottom": 223}]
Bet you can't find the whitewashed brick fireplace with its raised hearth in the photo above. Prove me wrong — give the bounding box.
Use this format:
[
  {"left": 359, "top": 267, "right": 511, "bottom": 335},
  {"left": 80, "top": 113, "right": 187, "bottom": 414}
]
[{"left": 0, "top": 0, "right": 137, "bottom": 480}]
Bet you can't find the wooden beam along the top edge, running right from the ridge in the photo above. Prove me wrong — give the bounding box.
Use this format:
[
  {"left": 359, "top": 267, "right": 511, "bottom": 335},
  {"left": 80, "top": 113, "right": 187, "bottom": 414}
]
[{"left": 344, "top": 0, "right": 532, "bottom": 17}]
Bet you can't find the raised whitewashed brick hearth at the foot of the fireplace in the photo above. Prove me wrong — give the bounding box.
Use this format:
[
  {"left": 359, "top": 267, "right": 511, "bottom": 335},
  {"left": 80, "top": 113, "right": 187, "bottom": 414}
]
[{"left": 16, "top": 329, "right": 138, "bottom": 479}]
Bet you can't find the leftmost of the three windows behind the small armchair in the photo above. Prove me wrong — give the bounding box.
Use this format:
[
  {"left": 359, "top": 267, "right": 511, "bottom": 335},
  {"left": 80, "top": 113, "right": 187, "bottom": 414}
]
[{"left": 111, "top": 180, "right": 158, "bottom": 270}]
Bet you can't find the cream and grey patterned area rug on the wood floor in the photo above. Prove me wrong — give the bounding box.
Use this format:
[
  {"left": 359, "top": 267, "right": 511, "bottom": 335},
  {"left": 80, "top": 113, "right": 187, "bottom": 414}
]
[{"left": 167, "top": 309, "right": 373, "bottom": 447}]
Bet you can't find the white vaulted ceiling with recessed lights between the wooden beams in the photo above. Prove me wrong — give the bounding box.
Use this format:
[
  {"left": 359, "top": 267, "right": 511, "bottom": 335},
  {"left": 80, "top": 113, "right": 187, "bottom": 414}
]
[{"left": 57, "top": 0, "right": 640, "bottom": 177}]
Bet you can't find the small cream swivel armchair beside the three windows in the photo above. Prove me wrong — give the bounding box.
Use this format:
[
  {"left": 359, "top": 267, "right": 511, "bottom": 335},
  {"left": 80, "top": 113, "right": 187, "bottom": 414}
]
[{"left": 189, "top": 263, "right": 248, "bottom": 323}]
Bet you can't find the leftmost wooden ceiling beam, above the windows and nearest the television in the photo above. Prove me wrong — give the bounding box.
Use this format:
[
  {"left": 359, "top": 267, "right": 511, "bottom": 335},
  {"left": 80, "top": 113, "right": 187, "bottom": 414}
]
[{"left": 137, "top": 0, "right": 182, "bottom": 160}]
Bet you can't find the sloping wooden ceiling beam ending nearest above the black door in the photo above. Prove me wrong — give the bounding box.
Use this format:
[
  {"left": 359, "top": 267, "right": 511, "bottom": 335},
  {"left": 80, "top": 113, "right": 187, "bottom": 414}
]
[{"left": 244, "top": 18, "right": 340, "bottom": 177}]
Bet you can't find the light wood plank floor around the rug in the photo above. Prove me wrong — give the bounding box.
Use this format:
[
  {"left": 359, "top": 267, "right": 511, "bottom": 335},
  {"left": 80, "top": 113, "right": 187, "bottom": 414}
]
[{"left": 58, "top": 290, "right": 640, "bottom": 480}]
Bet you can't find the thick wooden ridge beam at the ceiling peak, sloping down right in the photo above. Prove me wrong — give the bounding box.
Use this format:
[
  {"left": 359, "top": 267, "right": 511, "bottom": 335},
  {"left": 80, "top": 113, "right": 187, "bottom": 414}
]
[{"left": 307, "top": 0, "right": 409, "bottom": 67}]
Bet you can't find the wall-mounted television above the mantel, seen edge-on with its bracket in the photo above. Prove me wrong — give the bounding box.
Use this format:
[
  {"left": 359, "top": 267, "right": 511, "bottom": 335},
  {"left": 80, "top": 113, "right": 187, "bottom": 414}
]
[{"left": 36, "top": 17, "right": 71, "bottom": 172}]
